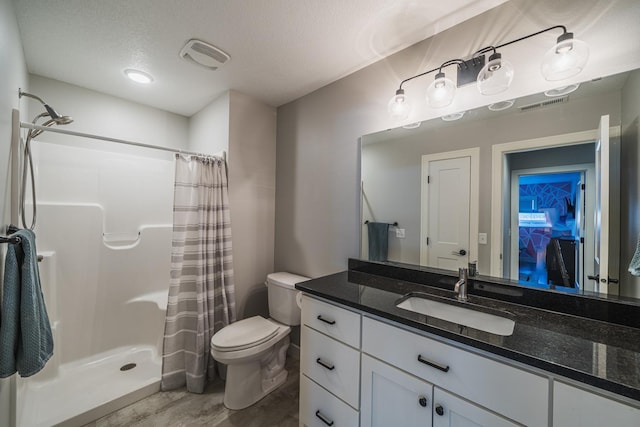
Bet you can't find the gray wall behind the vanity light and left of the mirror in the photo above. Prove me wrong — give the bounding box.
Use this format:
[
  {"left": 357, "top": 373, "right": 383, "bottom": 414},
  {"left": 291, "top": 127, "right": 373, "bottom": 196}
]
[{"left": 275, "top": 0, "right": 640, "bottom": 277}]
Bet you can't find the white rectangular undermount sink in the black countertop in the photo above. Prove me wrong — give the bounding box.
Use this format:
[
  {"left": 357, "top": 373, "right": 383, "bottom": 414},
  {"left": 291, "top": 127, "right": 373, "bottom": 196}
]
[{"left": 396, "top": 293, "right": 516, "bottom": 337}]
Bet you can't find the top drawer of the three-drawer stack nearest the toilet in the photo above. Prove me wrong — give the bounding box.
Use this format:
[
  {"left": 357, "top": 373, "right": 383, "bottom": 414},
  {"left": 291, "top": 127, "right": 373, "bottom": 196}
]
[{"left": 302, "top": 295, "right": 360, "bottom": 348}]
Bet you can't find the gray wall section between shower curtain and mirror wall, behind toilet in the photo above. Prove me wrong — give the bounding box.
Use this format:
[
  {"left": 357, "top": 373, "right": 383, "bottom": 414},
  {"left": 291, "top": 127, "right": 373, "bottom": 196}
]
[{"left": 189, "top": 90, "right": 276, "bottom": 319}]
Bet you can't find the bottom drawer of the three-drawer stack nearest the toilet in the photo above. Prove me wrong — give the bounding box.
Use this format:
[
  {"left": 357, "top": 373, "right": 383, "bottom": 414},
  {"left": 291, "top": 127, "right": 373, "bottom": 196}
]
[{"left": 300, "top": 375, "right": 358, "bottom": 427}]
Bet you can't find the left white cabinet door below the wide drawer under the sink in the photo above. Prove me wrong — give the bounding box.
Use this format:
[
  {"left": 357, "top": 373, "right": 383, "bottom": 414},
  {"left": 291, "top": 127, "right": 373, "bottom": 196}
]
[{"left": 360, "top": 355, "right": 433, "bottom": 427}]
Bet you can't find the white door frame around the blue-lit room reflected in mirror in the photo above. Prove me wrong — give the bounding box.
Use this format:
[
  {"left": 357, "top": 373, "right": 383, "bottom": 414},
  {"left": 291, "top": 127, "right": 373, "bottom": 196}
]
[{"left": 510, "top": 164, "right": 595, "bottom": 290}]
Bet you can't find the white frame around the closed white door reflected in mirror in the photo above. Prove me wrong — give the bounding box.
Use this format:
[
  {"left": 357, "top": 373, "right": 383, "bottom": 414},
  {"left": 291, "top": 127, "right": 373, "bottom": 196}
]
[{"left": 420, "top": 147, "right": 480, "bottom": 265}]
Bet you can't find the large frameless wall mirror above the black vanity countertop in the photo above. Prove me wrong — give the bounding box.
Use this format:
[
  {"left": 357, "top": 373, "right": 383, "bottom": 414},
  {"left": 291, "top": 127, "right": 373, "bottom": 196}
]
[{"left": 360, "top": 70, "right": 640, "bottom": 295}]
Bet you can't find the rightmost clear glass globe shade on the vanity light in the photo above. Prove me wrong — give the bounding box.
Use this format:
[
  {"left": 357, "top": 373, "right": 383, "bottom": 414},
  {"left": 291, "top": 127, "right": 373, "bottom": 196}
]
[{"left": 540, "top": 38, "right": 589, "bottom": 81}]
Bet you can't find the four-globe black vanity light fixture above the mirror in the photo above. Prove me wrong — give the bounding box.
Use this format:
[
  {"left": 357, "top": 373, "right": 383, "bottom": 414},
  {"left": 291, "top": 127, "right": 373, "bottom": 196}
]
[{"left": 387, "top": 25, "right": 589, "bottom": 121}]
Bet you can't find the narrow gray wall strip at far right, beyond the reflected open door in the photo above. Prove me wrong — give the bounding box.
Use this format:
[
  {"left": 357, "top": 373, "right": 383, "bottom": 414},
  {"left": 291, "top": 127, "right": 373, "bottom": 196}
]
[{"left": 620, "top": 71, "right": 640, "bottom": 298}]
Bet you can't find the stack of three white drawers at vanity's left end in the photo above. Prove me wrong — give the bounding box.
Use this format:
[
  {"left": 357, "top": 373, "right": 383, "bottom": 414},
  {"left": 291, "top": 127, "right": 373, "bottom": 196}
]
[{"left": 300, "top": 295, "right": 361, "bottom": 427}]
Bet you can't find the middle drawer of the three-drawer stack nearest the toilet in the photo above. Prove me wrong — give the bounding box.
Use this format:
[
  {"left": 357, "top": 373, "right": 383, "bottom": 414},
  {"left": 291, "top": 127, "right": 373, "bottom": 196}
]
[{"left": 300, "top": 326, "right": 360, "bottom": 408}]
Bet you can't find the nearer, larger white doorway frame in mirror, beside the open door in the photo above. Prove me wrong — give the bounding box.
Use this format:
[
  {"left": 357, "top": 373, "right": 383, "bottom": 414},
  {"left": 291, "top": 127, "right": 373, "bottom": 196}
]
[{"left": 490, "top": 126, "right": 620, "bottom": 277}]
